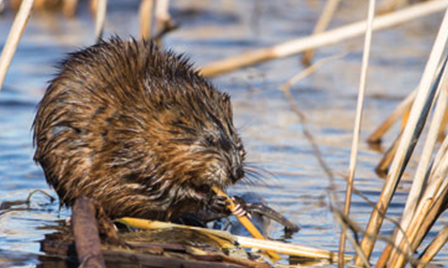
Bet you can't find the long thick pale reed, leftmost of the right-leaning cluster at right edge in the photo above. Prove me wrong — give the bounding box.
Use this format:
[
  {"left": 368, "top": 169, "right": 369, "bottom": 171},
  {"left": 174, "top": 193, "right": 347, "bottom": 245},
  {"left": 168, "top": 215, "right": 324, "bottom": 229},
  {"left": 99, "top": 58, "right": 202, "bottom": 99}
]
[{"left": 355, "top": 7, "right": 448, "bottom": 265}]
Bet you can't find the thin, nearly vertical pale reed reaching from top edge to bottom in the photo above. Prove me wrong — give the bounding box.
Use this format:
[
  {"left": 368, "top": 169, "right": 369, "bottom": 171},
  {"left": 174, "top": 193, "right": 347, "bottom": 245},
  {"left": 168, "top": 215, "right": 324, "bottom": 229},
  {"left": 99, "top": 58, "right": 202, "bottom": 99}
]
[{"left": 338, "top": 0, "right": 375, "bottom": 268}]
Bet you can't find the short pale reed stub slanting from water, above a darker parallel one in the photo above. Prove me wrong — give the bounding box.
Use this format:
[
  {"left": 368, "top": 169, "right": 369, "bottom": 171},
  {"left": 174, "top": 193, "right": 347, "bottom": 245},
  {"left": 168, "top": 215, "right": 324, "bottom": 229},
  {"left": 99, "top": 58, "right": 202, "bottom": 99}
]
[{"left": 367, "top": 90, "right": 417, "bottom": 143}]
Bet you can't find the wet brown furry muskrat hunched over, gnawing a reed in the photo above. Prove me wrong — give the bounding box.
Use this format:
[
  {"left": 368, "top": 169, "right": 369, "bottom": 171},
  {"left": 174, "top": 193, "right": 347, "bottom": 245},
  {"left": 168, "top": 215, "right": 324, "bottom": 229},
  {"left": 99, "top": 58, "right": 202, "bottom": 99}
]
[{"left": 34, "top": 37, "right": 245, "bottom": 220}]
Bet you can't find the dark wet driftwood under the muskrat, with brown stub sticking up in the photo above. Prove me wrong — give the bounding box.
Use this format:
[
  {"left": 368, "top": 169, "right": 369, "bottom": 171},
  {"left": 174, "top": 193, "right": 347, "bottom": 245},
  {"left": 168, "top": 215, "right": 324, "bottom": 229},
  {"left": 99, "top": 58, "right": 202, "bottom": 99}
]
[{"left": 39, "top": 206, "right": 270, "bottom": 268}]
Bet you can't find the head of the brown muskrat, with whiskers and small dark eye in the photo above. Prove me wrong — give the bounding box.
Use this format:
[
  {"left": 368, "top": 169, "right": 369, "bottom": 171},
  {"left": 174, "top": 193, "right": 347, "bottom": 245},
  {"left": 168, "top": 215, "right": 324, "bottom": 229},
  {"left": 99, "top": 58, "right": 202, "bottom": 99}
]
[{"left": 146, "top": 86, "right": 246, "bottom": 205}]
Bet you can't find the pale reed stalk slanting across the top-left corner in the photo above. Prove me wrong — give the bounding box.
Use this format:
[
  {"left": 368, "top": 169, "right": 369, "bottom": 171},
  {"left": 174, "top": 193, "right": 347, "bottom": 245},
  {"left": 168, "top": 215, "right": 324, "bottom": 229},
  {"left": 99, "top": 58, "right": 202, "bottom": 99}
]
[{"left": 0, "top": 0, "right": 34, "bottom": 91}]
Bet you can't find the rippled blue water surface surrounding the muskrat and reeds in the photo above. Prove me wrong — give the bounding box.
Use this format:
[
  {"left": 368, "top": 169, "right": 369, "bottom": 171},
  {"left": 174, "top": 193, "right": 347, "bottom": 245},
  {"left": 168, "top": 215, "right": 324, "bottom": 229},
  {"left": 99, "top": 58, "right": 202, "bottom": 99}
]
[{"left": 0, "top": 0, "right": 448, "bottom": 266}]
